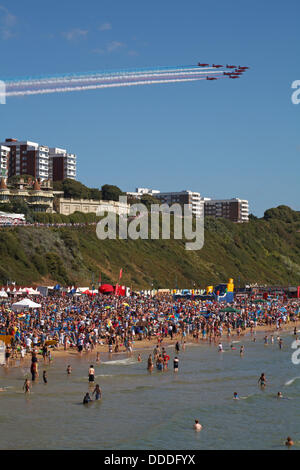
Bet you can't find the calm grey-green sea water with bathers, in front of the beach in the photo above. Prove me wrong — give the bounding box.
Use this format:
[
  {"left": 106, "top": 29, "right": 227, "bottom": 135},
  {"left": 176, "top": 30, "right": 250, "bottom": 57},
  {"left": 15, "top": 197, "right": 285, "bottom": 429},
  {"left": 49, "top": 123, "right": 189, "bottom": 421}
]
[{"left": 0, "top": 333, "right": 300, "bottom": 450}]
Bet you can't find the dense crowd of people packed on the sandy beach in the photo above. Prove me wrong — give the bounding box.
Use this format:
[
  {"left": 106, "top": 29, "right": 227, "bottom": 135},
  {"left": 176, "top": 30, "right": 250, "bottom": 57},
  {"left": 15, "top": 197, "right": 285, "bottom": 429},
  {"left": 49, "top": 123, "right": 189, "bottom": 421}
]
[{"left": 0, "top": 294, "right": 300, "bottom": 370}]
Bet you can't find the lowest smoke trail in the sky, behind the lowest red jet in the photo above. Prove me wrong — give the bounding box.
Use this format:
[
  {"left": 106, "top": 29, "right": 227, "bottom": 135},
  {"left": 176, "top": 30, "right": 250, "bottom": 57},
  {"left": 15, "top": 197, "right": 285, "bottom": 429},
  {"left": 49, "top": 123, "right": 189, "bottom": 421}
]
[{"left": 6, "top": 77, "right": 214, "bottom": 97}]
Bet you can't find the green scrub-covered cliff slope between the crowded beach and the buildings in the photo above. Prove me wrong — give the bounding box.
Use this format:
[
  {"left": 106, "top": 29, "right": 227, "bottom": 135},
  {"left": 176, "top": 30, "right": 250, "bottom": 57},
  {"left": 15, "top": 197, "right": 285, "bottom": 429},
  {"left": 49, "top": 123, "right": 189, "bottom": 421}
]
[{"left": 0, "top": 206, "right": 300, "bottom": 289}]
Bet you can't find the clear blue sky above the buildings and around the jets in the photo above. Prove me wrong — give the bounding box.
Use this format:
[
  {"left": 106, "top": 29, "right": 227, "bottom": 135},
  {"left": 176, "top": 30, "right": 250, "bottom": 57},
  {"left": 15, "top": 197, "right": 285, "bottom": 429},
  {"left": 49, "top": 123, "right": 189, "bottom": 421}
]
[{"left": 0, "top": 0, "right": 300, "bottom": 216}]
